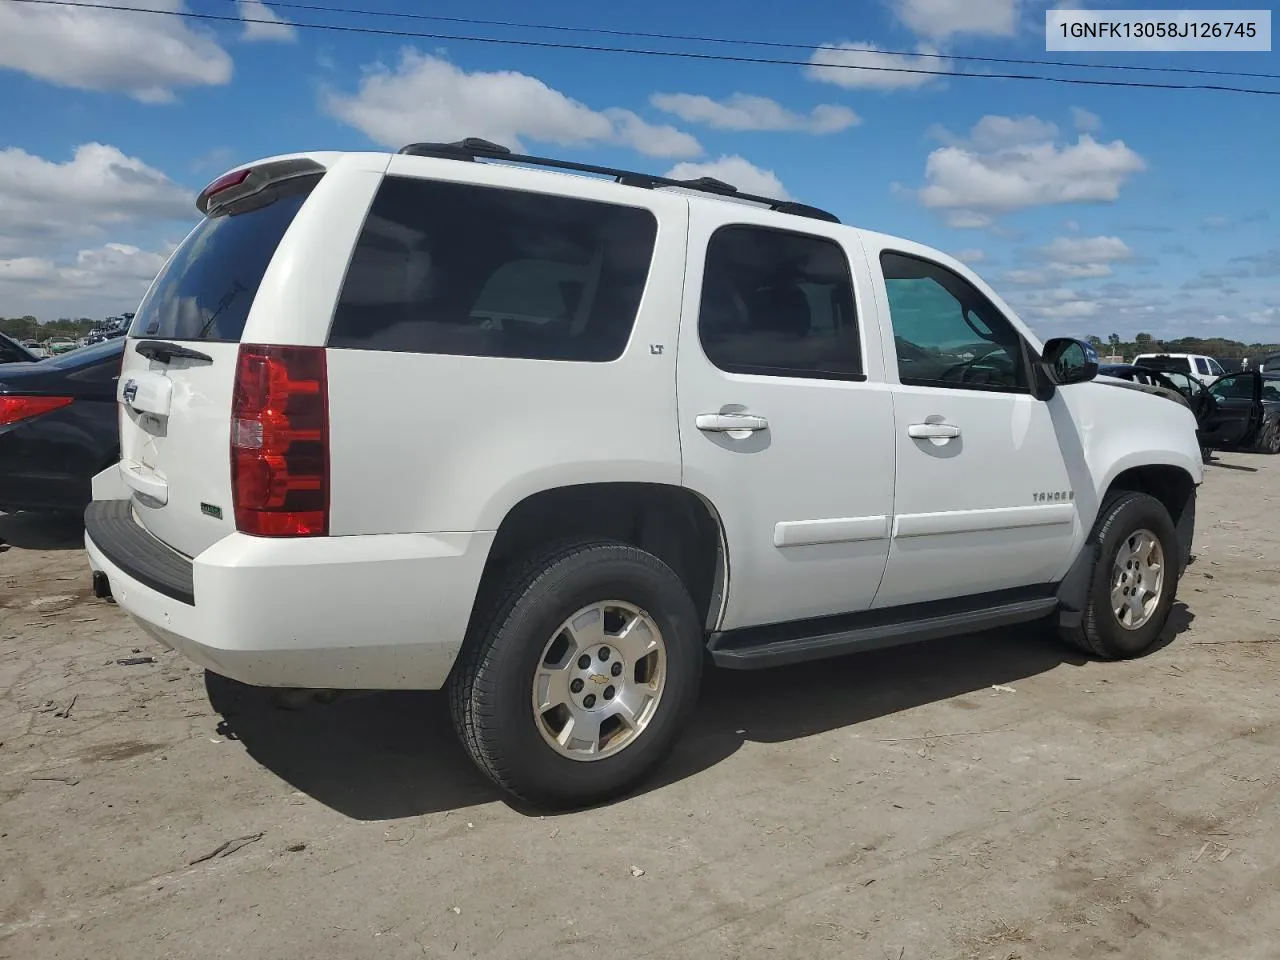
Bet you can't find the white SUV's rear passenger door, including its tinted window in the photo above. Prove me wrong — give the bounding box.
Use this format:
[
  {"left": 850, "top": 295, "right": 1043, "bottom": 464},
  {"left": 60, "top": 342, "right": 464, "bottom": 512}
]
[{"left": 677, "top": 212, "right": 895, "bottom": 630}]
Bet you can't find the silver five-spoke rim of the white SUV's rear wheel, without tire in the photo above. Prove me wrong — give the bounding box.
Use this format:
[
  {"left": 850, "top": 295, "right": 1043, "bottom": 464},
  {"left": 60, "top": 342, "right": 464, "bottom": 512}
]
[{"left": 532, "top": 600, "right": 667, "bottom": 760}]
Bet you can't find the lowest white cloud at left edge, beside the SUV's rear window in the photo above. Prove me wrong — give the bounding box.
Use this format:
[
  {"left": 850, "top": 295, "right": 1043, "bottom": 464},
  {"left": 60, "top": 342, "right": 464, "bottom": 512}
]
[{"left": 0, "top": 243, "right": 170, "bottom": 320}]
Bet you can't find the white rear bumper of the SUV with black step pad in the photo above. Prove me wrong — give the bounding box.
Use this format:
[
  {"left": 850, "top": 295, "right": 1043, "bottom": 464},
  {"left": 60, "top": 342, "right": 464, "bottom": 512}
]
[{"left": 84, "top": 500, "right": 493, "bottom": 690}]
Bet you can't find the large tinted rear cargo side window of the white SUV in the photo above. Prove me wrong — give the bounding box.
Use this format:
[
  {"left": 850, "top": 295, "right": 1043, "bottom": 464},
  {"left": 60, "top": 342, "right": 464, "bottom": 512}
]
[{"left": 329, "top": 177, "right": 658, "bottom": 362}]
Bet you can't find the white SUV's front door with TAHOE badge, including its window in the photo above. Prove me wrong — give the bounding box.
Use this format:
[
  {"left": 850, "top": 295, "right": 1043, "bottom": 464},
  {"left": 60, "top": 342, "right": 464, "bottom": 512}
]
[{"left": 868, "top": 250, "right": 1079, "bottom": 608}]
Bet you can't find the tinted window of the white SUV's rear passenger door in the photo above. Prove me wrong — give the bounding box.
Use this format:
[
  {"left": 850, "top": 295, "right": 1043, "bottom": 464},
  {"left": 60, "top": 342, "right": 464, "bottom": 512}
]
[{"left": 698, "top": 225, "right": 864, "bottom": 380}]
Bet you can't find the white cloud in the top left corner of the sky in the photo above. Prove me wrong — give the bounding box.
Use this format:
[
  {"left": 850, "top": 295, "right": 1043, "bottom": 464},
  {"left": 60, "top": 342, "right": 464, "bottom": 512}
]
[{"left": 0, "top": 0, "right": 232, "bottom": 102}]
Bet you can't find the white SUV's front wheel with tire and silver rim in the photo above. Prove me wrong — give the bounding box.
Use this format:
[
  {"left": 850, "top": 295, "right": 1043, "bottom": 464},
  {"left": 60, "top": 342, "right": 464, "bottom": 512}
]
[{"left": 1064, "top": 492, "right": 1183, "bottom": 660}]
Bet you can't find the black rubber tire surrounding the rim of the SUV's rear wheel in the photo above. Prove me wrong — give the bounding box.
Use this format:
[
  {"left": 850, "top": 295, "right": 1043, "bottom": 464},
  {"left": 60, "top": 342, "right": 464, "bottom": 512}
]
[{"left": 448, "top": 540, "right": 705, "bottom": 809}]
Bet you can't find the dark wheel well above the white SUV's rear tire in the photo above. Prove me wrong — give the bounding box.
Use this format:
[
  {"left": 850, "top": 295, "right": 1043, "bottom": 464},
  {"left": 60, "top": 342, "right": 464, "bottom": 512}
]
[{"left": 485, "top": 483, "right": 726, "bottom": 625}]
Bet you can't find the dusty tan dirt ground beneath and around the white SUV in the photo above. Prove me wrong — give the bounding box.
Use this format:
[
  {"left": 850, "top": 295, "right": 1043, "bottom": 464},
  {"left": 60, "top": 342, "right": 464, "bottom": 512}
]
[{"left": 0, "top": 454, "right": 1280, "bottom": 960}]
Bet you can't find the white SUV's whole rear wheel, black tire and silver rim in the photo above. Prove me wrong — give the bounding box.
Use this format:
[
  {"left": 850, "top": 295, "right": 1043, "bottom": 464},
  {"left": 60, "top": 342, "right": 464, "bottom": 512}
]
[{"left": 448, "top": 540, "right": 703, "bottom": 808}]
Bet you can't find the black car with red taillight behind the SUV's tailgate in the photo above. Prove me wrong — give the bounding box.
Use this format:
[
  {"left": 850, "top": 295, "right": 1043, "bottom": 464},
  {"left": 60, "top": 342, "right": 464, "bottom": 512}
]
[{"left": 0, "top": 339, "right": 124, "bottom": 513}]
